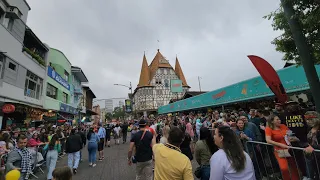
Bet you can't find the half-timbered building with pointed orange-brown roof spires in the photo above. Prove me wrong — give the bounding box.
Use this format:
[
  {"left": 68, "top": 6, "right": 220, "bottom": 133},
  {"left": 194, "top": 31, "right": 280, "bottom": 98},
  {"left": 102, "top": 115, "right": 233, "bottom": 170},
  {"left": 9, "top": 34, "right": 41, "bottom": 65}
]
[{"left": 133, "top": 50, "right": 190, "bottom": 115}]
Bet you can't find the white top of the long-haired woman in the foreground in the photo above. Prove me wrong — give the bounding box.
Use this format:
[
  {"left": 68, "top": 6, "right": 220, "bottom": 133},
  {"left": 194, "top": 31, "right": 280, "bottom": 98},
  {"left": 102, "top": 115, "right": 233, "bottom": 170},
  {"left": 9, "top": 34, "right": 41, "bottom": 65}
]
[{"left": 210, "top": 149, "right": 256, "bottom": 180}]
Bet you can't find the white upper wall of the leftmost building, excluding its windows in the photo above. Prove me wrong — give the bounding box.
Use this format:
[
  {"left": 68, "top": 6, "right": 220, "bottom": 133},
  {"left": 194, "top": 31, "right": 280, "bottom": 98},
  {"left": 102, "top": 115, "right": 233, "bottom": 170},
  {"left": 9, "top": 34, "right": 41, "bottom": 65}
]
[{"left": 0, "top": 0, "right": 46, "bottom": 106}]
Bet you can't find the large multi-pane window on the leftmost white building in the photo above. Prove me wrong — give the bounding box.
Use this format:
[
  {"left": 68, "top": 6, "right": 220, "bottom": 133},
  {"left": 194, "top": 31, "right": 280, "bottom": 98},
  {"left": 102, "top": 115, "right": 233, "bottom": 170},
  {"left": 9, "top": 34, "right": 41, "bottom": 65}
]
[{"left": 24, "top": 70, "right": 43, "bottom": 99}]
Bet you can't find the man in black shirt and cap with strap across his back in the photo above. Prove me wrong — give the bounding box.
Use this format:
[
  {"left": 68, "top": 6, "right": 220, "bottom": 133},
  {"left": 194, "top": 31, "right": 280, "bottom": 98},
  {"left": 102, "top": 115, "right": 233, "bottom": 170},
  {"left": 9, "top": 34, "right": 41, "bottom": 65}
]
[{"left": 128, "top": 119, "right": 153, "bottom": 180}]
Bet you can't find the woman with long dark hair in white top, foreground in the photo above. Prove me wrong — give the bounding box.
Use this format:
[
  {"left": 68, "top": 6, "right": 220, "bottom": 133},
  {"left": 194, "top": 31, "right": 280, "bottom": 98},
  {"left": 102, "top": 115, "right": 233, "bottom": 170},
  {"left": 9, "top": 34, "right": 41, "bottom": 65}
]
[{"left": 210, "top": 126, "right": 256, "bottom": 180}]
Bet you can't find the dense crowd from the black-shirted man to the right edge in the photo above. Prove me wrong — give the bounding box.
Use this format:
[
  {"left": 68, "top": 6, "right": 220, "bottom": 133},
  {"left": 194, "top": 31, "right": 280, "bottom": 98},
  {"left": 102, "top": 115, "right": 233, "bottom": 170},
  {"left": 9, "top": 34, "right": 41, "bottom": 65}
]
[{"left": 128, "top": 101, "right": 320, "bottom": 180}]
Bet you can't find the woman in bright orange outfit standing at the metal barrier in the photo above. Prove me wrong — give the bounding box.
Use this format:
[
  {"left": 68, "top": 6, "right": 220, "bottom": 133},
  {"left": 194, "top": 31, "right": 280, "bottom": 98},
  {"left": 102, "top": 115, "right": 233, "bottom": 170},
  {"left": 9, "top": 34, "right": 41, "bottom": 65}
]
[{"left": 265, "top": 115, "right": 299, "bottom": 180}]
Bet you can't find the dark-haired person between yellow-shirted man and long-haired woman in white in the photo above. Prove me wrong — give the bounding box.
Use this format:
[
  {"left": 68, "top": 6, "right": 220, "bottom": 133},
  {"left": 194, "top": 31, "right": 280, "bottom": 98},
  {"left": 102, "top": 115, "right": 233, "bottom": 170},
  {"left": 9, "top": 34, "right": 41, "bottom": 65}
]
[{"left": 194, "top": 127, "right": 218, "bottom": 180}]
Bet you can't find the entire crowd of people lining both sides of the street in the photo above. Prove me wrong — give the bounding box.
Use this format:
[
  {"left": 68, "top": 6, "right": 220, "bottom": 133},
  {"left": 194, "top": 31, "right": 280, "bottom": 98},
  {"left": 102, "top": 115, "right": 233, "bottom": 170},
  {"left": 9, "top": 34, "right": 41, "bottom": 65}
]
[{"left": 0, "top": 99, "right": 320, "bottom": 180}]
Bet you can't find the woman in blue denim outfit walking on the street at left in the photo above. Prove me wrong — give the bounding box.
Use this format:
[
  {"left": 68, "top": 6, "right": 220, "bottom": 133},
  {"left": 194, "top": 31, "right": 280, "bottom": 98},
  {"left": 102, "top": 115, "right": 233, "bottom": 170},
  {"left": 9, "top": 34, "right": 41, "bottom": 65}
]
[{"left": 87, "top": 128, "right": 100, "bottom": 167}]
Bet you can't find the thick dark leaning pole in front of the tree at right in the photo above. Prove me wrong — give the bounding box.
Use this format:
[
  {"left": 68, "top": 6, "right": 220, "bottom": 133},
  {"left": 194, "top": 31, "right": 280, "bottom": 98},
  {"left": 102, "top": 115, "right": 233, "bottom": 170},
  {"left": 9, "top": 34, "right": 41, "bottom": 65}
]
[{"left": 281, "top": 0, "right": 320, "bottom": 112}]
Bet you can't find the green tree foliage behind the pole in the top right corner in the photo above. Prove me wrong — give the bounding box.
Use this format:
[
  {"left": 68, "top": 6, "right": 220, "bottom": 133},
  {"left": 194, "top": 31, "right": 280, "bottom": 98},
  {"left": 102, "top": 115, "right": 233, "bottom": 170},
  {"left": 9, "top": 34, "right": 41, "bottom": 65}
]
[{"left": 264, "top": 0, "right": 320, "bottom": 64}]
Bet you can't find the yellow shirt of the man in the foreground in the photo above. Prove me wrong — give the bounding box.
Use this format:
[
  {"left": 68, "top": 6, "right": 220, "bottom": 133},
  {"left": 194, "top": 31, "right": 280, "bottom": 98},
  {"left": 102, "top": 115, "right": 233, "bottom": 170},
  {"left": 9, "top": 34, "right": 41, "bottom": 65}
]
[{"left": 152, "top": 144, "right": 194, "bottom": 180}]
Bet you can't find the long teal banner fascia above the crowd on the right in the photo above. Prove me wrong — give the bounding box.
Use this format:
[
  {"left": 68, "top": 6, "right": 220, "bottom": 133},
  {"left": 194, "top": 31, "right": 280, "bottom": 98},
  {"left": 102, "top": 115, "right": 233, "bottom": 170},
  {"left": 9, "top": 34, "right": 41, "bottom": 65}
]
[{"left": 158, "top": 65, "right": 320, "bottom": 114}]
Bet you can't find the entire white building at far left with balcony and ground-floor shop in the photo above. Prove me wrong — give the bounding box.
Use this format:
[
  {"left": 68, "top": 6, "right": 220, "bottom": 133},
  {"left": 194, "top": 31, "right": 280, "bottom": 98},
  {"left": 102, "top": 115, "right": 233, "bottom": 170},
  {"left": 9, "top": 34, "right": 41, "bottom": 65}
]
[{"left": 0, "top": 0, "right": 53, "bottom": 128}]
